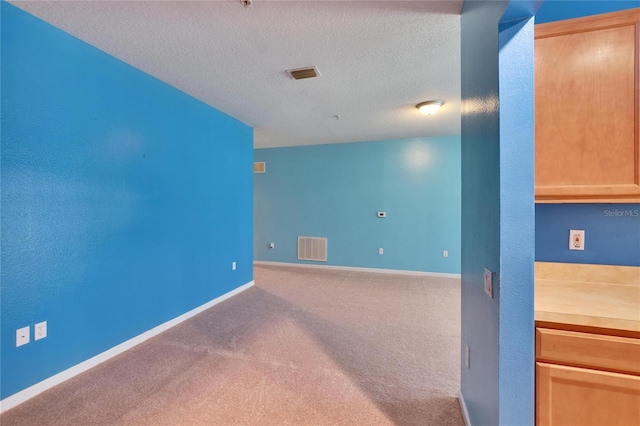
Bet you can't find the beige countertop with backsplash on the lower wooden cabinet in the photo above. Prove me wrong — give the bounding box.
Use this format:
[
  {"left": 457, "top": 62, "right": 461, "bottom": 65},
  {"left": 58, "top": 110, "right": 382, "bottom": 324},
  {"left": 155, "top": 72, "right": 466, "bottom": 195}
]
[{"left": 535, "top": 262, "right": 640, "bottom": 332}]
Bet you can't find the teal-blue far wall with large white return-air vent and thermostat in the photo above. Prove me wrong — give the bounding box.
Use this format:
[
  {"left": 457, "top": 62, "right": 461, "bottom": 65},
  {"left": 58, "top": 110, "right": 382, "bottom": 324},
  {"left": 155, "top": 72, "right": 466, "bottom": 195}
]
[{"left": 254, "top": 136, "right": 460, "bottom": 274}]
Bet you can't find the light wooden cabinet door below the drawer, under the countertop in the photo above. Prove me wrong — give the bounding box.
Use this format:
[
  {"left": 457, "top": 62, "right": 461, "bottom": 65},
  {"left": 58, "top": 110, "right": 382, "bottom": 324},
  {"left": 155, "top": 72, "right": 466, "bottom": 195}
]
[{"left": 536, "top": 363, "right": 640, "bottom": 426}]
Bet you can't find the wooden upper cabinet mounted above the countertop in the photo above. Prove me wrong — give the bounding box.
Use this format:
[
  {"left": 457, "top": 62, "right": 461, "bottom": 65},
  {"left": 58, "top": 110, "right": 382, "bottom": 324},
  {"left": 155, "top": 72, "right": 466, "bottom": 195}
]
[{"left": 535, "top": 8, "right": 640, "bottom": 203}]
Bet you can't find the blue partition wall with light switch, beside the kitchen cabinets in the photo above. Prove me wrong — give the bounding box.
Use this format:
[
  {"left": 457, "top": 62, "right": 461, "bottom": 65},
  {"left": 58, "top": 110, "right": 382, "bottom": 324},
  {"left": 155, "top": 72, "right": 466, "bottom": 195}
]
[{"left": 461, "top": 1, "right": 536, "bottom": 425}]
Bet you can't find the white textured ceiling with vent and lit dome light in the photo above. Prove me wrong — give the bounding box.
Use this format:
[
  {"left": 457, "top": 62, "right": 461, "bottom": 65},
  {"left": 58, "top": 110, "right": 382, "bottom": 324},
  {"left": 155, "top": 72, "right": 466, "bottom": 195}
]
[{"left": 11, "top": 0, "right": 462, "bottom": 148}]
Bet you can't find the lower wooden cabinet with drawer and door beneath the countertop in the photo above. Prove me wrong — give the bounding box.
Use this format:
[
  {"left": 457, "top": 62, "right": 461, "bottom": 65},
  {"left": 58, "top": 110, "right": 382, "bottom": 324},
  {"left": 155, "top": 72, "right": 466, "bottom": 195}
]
[{"left": 536, "top": 327, "right": 640, "bottom": 426}]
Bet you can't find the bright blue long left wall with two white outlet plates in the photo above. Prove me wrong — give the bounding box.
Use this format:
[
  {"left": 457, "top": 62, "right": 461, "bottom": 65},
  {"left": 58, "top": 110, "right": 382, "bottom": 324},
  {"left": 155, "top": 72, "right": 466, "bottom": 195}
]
[{"left": 1, "top": 2, "right": 253, "bottom": 398}]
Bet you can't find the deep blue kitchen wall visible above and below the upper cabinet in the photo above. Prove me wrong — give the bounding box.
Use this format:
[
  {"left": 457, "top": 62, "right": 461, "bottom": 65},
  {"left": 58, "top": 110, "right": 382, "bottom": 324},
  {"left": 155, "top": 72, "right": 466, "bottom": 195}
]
[{"left": 535, "top": 0, "right": 640, "bottom": 266}]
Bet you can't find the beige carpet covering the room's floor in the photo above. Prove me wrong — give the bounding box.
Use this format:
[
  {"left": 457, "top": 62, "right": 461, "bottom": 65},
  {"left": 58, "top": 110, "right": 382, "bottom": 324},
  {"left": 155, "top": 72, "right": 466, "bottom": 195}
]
[{"left": 0, "top": 266, "right": 464, "bottom": 426}]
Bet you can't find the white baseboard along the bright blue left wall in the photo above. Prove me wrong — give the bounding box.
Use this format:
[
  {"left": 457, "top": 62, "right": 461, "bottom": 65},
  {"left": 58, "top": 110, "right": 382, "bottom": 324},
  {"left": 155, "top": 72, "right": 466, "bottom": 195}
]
[{"left": 0, "top": 281, "right": 254, "bottom": 413}]
